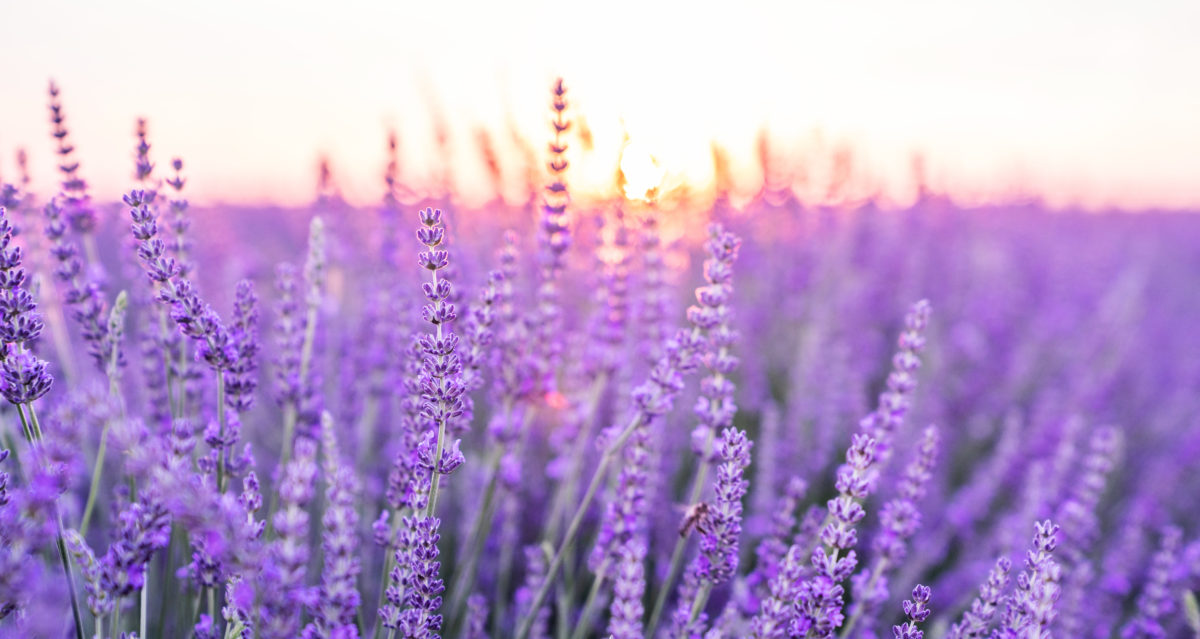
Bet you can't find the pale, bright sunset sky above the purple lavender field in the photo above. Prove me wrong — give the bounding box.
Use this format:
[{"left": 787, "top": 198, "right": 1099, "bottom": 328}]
[{"left": 0, "top": 0, "right": 1200, "bottom": 209}]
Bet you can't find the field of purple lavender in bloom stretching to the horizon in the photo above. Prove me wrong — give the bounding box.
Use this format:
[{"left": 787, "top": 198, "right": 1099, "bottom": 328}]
[{"left": 0, "top": 83, "right": 1200, "bottom": 639}]
